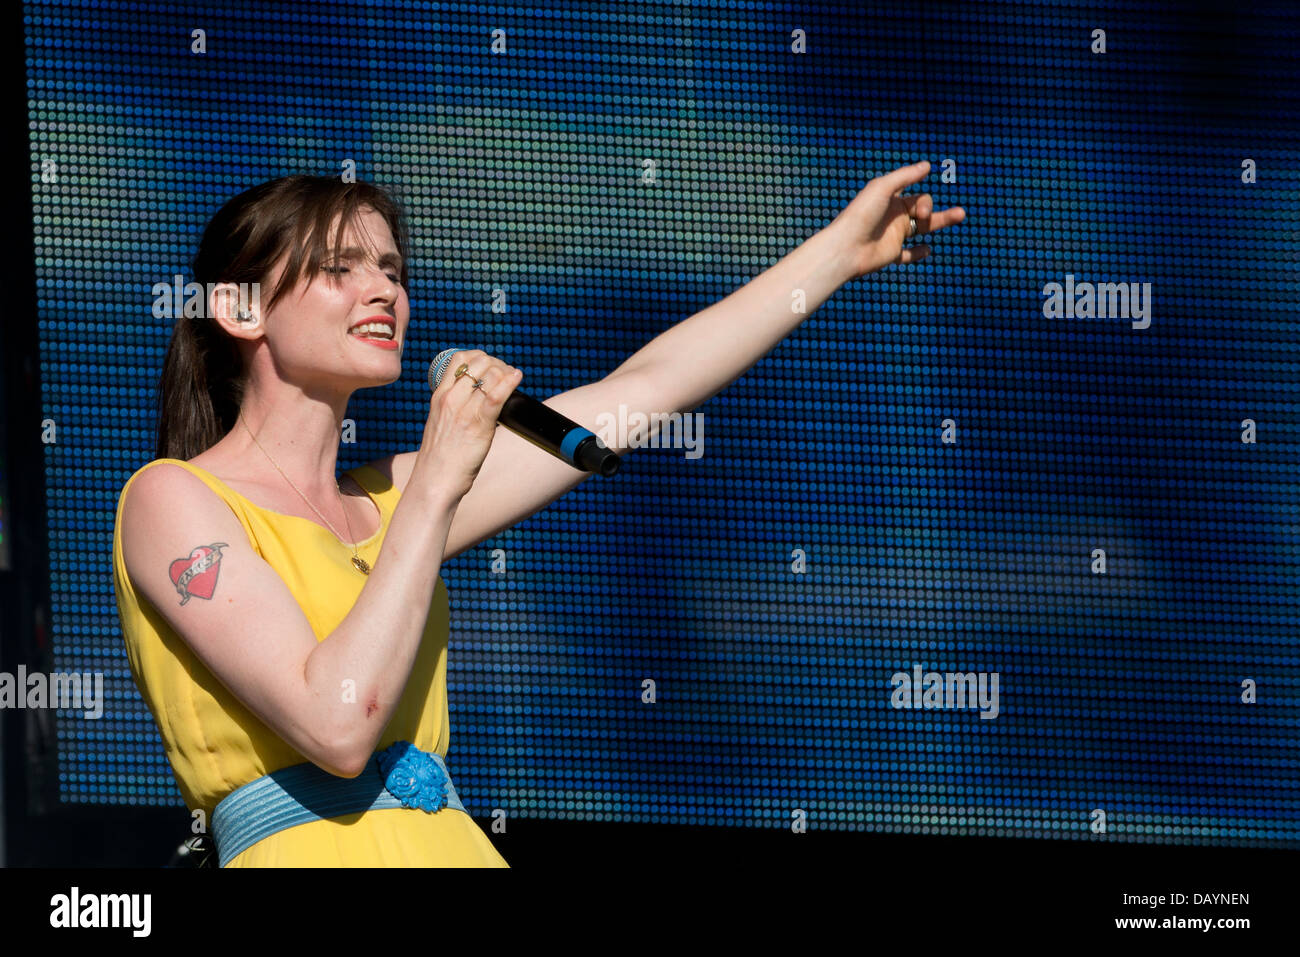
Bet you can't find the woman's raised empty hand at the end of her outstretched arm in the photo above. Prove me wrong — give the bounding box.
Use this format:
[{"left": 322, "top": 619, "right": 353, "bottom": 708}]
[{"left": 828, "top": 160, "right": 966, "bottom": 278}]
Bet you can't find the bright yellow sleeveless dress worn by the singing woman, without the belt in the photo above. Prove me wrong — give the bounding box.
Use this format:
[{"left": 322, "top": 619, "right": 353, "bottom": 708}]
[{"left": 113, "top": 459, "right": 508, "bottom": 867}]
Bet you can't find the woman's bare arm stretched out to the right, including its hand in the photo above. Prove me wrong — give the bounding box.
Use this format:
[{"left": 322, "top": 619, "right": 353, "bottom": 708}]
[{"left": 395, "top": 161, "right": 966, "bottom": 559}]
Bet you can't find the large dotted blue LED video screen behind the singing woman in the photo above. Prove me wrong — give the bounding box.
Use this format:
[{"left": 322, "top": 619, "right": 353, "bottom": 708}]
[{"left": 26, "top": 3, "right": 1300, "bottom": 846}]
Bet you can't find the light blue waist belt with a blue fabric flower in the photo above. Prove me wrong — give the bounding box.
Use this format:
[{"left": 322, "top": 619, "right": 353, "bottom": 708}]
[{"left": 212, "top": 741, "right": 468, "bottom": 867}]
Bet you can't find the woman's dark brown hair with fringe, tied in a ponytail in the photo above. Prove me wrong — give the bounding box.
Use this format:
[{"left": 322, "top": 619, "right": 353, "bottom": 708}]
[{"left": 155, "top": 176, "right": 408, "bottom": 459}]
